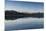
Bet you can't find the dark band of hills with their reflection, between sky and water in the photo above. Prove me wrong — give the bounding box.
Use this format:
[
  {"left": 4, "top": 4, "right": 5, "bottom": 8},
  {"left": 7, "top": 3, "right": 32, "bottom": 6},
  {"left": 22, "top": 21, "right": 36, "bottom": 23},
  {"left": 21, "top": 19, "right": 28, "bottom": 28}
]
[{"left": 5, "top": 10, "right": 44, "bottom": 20}]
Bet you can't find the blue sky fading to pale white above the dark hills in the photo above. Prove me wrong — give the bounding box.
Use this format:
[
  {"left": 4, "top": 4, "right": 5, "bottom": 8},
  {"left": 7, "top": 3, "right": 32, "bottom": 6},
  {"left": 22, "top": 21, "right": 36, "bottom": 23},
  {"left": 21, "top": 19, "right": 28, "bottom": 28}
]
[{"left": 5, "top": 0, "right": 44, "bottom": 13}]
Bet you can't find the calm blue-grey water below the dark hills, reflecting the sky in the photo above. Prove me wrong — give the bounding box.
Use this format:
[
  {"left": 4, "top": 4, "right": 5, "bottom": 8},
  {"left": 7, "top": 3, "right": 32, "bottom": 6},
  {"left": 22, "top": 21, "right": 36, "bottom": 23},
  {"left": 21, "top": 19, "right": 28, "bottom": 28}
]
[{"left": 5, "top": 17, "right": 44, "bottom": 30}]
